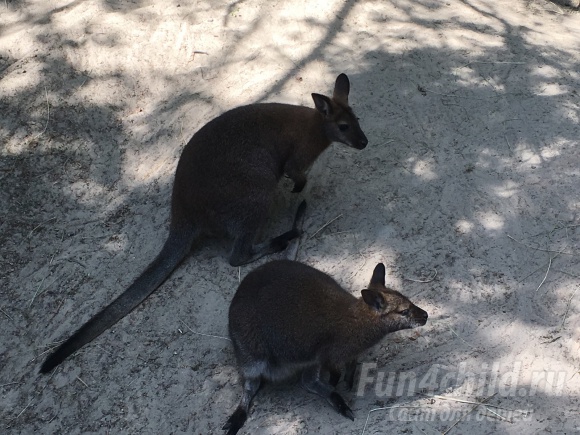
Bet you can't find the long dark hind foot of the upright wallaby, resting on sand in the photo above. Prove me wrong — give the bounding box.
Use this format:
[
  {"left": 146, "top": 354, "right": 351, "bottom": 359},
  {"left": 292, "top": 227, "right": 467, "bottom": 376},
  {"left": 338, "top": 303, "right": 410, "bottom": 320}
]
[{"left": 230, "top": 201, "right": 306, "bottom": 266}]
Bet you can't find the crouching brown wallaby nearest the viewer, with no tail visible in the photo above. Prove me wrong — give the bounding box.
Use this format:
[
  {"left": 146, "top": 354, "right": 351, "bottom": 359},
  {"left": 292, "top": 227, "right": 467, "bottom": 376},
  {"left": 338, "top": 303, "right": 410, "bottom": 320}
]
[{"left": 223, "top": 260, "right": 427, "bottom": 435}]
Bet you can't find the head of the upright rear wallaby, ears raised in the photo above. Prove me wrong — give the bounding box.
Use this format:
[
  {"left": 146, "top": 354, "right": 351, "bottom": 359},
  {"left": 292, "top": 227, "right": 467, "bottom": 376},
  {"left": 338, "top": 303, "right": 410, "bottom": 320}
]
[{"left": 312, "top": 74, "right": 369, "bottom": 150}]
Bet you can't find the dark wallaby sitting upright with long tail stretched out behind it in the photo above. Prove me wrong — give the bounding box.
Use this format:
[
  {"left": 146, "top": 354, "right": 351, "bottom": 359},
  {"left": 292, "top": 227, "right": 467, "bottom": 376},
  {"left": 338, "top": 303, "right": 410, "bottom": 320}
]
[{"left": 40, "top": 74, "right": 368, "bottom": 373}]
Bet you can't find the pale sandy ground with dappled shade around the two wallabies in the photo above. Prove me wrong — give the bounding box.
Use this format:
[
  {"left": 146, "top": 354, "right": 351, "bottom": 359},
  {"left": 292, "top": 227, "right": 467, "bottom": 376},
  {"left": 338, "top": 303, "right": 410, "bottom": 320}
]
[{"left": 0, "top": 0, "right": 580, "bottom": 435}]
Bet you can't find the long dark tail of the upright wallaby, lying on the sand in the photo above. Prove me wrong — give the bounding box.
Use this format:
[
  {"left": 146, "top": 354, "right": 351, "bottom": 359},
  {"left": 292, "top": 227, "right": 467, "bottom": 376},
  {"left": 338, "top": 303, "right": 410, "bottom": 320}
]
[{"left": 40, "top": 227, "right": 195, "bottom": 373}]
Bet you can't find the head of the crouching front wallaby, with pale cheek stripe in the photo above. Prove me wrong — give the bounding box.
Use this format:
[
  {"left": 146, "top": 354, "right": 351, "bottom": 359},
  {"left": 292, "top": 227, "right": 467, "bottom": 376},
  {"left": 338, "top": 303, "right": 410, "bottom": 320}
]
[{"left": 360, "top": 263, "right": 428, "bottom": 332}]
